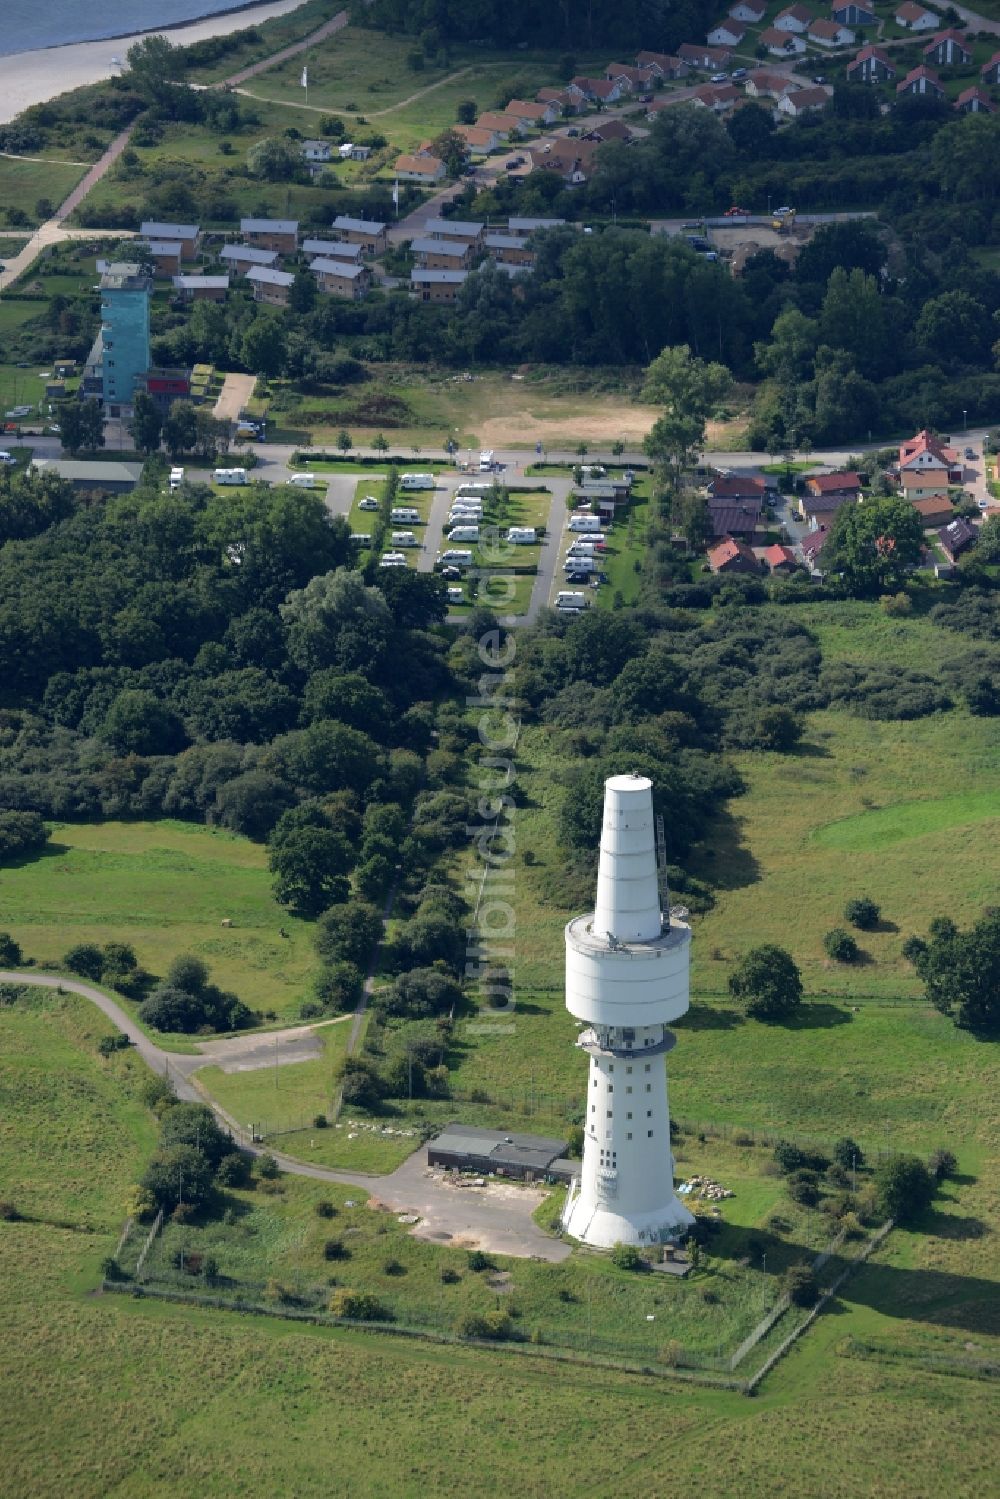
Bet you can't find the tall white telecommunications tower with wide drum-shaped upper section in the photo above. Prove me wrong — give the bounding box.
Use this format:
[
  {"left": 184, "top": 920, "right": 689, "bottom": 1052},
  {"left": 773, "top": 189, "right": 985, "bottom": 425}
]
[{"left": 562, "top": 775, "right": 694, "bottom": 1247}]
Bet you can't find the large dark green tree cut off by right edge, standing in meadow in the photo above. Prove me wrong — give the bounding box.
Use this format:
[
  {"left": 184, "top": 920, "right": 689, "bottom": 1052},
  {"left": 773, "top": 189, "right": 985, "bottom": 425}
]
[{"left": 915, "top": 907, "right": 1000, "bottom": 1031}]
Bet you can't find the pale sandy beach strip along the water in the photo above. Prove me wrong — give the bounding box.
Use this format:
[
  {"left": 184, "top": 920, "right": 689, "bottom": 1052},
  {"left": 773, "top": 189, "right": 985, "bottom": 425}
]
[{"left": 0, "top": 0, "right": 301, "bottom": 124}]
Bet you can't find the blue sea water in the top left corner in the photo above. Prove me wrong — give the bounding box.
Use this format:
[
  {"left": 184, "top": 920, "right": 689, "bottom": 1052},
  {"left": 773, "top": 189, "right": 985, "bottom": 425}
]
[{"left": 0, "top": 0, "right": 260, "bottom": 57}]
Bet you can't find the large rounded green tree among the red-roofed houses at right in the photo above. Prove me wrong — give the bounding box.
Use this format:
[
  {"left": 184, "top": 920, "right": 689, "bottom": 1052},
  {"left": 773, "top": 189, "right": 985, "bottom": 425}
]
[{"left": 823, "top": 499, "right": 924, "bottom": 598}]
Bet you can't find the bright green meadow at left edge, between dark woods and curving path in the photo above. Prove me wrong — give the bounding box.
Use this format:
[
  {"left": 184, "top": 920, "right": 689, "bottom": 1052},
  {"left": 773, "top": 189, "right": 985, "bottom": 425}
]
[{"left": 0, "top": 820, "right": 312, "bottom": 1019}]
